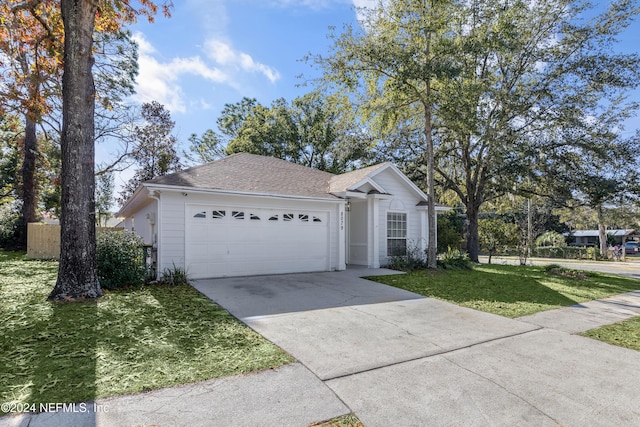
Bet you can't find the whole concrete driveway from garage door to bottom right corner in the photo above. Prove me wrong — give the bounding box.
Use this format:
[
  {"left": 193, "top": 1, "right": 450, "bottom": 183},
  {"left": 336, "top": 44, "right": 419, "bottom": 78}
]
[{"left": 194, "top": 270, "right": 640, "bottom": 427}]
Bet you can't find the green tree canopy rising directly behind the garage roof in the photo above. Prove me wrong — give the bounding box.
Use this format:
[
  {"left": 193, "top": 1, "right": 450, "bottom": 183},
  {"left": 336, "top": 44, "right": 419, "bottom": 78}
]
[{"left": 190, "top": 91, "right": 372, "bottom": 173}]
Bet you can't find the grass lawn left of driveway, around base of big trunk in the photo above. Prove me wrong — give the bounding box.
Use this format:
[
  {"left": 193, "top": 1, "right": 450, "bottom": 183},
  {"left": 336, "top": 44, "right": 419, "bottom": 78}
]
[{"left": 0, "top": 251, "right": 292, "bottom": 412}]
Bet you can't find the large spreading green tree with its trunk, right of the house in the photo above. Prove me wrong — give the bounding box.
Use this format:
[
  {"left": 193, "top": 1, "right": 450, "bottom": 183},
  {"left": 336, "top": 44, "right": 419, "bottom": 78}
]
[{"left": 315, "top": 0, "right": 640, "bottom": 261}]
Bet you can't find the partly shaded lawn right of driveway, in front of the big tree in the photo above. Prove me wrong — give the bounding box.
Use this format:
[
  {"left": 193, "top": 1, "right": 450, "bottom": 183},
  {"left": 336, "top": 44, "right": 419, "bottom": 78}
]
[{"left": 370, "top": 265, "right": 640, "bottom": 318}]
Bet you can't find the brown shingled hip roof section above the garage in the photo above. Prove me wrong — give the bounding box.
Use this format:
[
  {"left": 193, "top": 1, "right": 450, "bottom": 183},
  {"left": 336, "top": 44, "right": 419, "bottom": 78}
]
[{"left": 146, "top": 153, "right": 340, "bottom": 199}]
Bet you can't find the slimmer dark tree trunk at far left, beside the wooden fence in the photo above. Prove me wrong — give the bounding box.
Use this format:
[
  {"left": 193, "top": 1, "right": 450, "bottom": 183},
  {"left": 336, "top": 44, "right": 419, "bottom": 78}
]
[{"left": 18, "top": 114, "right": 38, "bottom": 249}]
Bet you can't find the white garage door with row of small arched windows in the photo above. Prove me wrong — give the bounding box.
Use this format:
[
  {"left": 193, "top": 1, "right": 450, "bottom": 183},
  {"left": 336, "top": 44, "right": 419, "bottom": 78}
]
[{"left": 185, "top": 205, "right": 329, "bottom": 279}]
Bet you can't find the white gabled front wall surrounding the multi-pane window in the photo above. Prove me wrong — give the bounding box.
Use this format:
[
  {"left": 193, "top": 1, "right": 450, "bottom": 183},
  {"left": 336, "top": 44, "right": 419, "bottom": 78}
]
[{"left": 373, "top": 169, "right": 428, "bottom": 265}]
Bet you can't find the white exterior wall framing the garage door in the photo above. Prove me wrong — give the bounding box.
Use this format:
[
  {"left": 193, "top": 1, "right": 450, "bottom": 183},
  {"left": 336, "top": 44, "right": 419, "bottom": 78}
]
[{"left": 156, "top": 191, "right": 344, "bottom": 272}]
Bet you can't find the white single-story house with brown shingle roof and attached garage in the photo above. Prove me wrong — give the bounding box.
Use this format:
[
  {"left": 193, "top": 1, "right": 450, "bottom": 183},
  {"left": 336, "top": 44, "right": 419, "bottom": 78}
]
[{"left": 117, "top": 153, "right": 447, "bottom": 279}]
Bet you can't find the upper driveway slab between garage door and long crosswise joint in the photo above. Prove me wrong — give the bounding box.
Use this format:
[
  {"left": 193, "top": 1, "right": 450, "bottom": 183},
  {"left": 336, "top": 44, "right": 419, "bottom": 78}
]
[{"left": 194, "top": 269, "right": 539, "bottom": 380}]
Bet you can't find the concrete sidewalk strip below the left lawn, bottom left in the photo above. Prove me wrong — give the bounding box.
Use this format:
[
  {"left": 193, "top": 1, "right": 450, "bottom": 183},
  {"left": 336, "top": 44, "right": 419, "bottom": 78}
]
[{"left": 0, "top": 363, "right": 351, "bottom": 427}]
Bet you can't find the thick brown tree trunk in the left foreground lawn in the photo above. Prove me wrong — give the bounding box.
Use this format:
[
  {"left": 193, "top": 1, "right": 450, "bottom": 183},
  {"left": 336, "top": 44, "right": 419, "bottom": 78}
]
[{"left": 49, "top": 0, "right": 102, "bottom": 299}]
